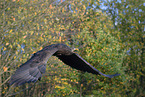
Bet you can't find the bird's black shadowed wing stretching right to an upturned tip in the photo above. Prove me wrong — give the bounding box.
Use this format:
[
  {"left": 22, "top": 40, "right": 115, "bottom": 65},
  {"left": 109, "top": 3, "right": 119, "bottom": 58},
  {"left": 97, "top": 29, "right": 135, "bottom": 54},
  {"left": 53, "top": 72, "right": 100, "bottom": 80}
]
[{"left": 57, "top": 53, "right": 120, "bottom": 78}]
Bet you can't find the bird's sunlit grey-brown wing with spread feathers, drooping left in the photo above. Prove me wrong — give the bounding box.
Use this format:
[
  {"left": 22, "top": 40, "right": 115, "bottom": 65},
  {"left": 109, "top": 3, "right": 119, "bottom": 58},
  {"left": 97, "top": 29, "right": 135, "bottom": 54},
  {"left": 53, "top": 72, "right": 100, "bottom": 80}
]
[{"left": 9, "top": 49, "right": 57, "bottom": 86}]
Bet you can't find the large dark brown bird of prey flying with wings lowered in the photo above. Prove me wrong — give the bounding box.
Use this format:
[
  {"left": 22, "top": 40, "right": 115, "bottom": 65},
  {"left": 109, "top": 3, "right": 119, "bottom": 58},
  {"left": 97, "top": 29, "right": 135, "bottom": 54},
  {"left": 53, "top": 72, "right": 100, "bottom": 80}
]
[{"left": 9, "top": 44, "right": 120, "bottom": 86}]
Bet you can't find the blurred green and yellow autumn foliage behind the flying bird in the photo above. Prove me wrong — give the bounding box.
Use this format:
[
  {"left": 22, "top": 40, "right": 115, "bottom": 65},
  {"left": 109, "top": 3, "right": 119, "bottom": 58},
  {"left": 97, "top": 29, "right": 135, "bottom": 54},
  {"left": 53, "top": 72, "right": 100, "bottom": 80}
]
[{"left": 0, "top": 0, "right": 145, "bottom": 97}]
